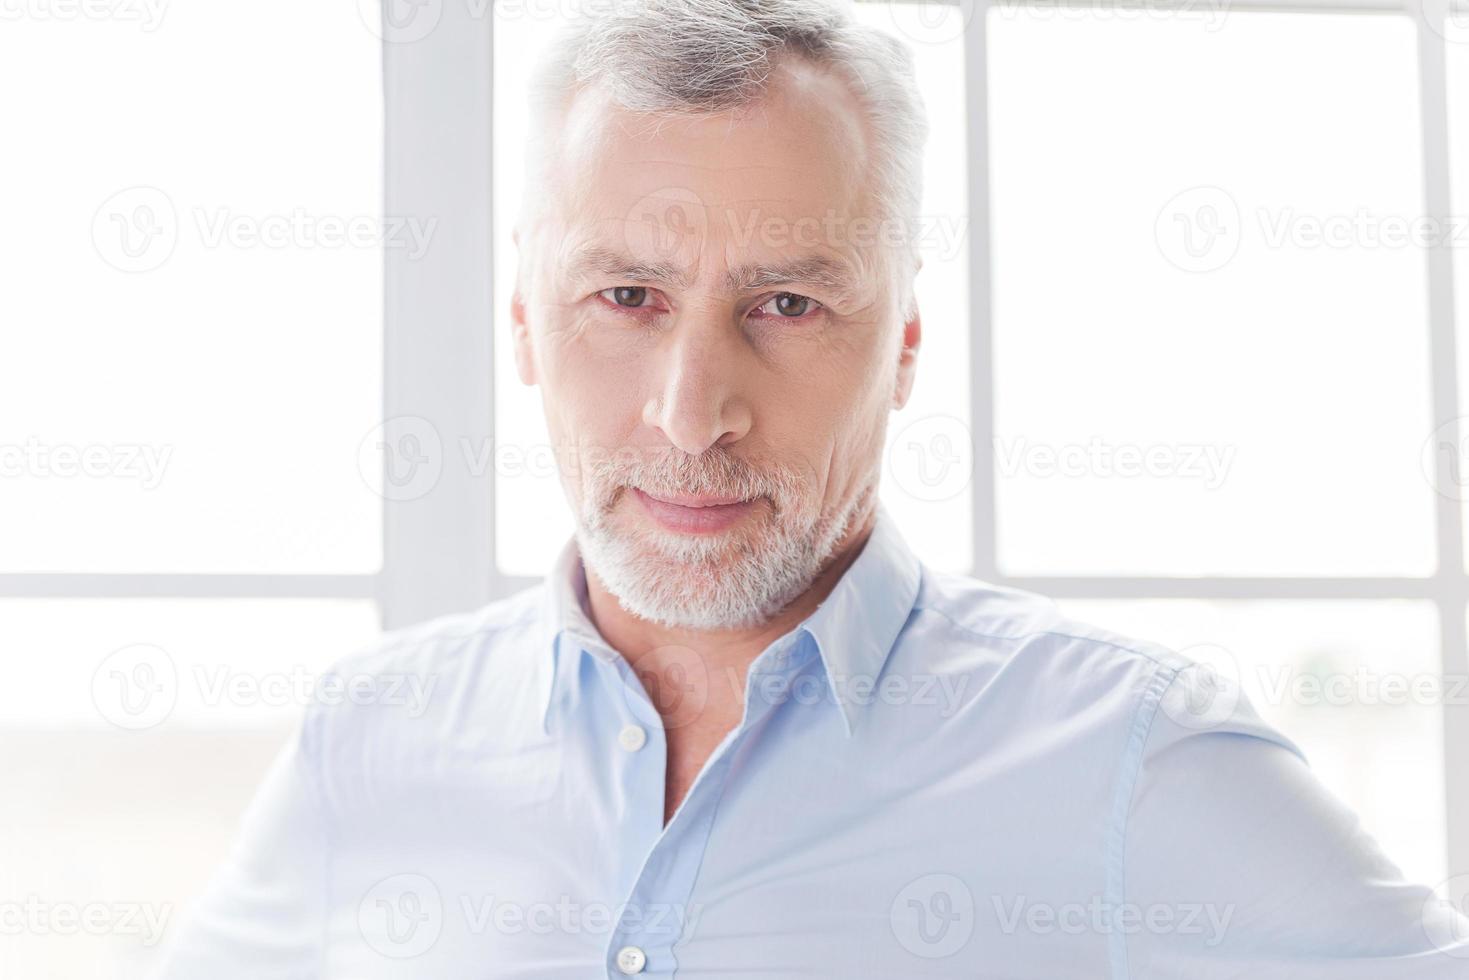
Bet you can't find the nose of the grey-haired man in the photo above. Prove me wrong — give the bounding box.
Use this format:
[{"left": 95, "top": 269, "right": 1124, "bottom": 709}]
[{"left": 643, "top": 314, "right": 751, "bottom": 455}]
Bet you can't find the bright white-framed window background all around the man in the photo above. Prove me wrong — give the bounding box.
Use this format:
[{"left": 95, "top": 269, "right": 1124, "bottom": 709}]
[{"left": 0, "top": 0, "right": 1469, "bottom": 980}]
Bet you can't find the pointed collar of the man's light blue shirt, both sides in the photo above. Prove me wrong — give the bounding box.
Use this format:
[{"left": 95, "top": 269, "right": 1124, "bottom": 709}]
[{"left": 539, "top": 501, "right": 923, "bottom": 735}]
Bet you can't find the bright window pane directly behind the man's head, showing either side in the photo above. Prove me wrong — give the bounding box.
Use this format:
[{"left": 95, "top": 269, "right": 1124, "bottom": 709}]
[{"left": 495, "top": 3, "right": 972, "bottom": 576}]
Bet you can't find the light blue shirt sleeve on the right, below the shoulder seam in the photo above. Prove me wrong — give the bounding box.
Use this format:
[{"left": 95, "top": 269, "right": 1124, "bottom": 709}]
[{"left": 1109, "top": 666, "right": 1469, "bottom": 980}]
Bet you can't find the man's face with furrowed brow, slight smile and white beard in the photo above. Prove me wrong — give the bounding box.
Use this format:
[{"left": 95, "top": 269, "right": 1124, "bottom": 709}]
[{"left": 514, "top": 63, "right": 917, "bottom": 629}]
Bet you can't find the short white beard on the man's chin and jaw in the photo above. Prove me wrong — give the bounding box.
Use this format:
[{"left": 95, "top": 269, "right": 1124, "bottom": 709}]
[{"left": 576, "top": 449, "right": 876, "bottom": 630}]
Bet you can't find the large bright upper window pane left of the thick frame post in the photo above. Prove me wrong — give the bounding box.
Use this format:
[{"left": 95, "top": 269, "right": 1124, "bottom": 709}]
[{"left": 0, "top": 0, "right": 392, "bottom": 573}]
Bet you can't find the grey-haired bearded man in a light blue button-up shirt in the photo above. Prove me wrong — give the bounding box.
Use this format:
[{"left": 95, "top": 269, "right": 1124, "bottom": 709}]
[{"left": 157, "top": 0, "right": 1469, "bottom": 980}]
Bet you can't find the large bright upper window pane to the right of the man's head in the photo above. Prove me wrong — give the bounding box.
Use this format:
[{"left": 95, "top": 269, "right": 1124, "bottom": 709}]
[{"left": 990, "top": 6, "right": 1434, "bottom": 574}]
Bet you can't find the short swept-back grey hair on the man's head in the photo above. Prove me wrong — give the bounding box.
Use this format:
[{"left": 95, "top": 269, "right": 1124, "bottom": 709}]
[{"left": 521, "top": 0, "right": 928, "bottom": 319}]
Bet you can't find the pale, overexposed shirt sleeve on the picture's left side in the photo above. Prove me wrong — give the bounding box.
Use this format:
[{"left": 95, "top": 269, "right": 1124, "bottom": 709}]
[{"left": 156, "top": 714, "right": 326, "bottom": 980}]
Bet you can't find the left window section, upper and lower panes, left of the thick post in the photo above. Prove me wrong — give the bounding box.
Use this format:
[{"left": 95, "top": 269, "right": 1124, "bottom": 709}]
[{"left": 0, "top": 0, "right": 384, "bottom": 979}]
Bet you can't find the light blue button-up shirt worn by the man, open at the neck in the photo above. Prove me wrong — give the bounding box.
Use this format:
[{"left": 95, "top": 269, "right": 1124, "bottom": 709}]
[{"left": 154, "top": 508, "right": 1469, "bottom": 980}]
